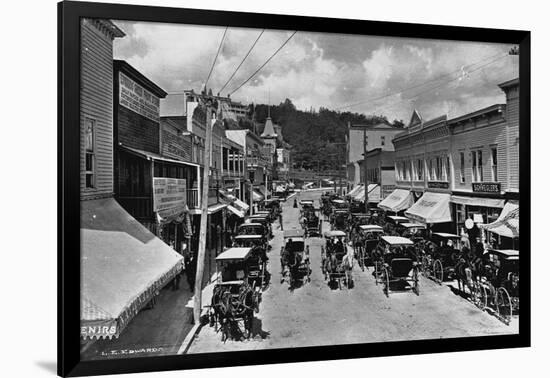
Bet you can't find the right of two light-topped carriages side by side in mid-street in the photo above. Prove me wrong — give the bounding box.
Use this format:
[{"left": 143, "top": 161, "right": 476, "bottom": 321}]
[{"left": 321, "top": 230, "right": 353, "bottom": 288}]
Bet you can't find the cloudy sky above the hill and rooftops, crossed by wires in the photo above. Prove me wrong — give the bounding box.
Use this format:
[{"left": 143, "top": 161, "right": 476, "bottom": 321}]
[{"left": 114, "top": 21, "right": 519, "bottom": 121}]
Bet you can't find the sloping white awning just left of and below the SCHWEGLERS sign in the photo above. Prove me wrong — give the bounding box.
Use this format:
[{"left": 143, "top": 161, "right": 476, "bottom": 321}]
[{"left": 405, "top": 192, "right": 452, "bottom": 223}]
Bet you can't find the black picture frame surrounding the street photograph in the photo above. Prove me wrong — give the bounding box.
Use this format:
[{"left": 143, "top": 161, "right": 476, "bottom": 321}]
[{"left": 58, "top": 1, "right": 531, "bottom": 376}]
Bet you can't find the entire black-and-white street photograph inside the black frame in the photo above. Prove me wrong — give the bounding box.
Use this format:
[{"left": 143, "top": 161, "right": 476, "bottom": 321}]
[{"left": 75, "top": 14, "right": 522, "bottom": 361}]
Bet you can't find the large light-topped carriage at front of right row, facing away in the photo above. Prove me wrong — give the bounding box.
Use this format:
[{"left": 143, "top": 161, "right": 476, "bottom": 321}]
[{"left": 373, "top": 236, "right": 420, "bottom": 296}]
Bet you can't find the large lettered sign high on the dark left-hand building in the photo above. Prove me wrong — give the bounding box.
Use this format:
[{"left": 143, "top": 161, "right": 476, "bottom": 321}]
[{"left": 118, "top": 72, "right": 160, "bottom": 122}]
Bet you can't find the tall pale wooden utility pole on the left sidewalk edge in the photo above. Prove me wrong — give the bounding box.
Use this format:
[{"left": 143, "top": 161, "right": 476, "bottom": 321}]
[{"left": 193, "top": 97, "right": 215, "bottom": 324}]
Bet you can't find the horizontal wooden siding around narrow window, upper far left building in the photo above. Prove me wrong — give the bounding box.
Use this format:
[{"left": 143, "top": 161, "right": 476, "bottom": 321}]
[{"left": 80, "top": 19, "right": 113, "bottom": 199}]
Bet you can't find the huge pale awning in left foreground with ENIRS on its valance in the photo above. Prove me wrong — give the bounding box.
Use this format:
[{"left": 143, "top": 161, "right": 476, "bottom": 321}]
[{"left": 80, "top": 198, "right": 182, "bottom": 339}]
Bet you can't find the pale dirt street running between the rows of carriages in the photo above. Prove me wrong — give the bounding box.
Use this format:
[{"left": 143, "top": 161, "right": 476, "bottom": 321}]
[{"left": 189, "top": 191, "right": 518, "bottom": 353}]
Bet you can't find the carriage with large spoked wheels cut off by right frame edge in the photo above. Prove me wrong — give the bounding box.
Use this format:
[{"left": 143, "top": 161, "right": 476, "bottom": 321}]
[{"left": 477, "top": 249, "right": 519, "bottom": 324}]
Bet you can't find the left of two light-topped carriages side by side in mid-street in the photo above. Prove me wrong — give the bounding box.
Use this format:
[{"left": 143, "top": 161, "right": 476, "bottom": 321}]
[{"left": 281, "top": 229, "right": 311, "bottom": 288}]
